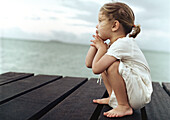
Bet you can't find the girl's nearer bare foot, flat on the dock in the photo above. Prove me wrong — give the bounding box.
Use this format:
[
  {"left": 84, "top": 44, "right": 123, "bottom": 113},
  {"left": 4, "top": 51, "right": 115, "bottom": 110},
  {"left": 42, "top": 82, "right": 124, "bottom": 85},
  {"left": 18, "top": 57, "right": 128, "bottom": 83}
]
[{"left": 104, "top": 105, "right": 133, "bottom": 117}]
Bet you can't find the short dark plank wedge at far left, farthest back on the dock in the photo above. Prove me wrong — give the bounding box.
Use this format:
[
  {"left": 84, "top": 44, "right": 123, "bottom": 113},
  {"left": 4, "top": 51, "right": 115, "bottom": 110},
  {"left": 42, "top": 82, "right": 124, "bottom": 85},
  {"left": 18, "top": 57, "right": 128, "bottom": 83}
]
[{"left": 0, "top": 72, "right": 34, "bottom": 86}]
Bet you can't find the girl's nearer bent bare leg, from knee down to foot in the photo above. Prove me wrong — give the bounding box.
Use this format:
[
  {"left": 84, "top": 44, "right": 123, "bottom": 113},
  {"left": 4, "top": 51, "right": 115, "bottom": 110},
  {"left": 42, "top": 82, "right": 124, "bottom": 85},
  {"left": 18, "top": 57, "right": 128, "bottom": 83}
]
[{"left": 104, "top": 61, "right": 133, "bottom": 117}]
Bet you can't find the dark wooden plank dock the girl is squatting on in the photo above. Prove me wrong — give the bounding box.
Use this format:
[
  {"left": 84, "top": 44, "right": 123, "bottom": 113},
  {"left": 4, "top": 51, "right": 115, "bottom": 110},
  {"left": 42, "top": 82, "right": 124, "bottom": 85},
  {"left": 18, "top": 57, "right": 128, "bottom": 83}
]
[{"left": 0, "top": 72, "right": 170, "bottom": 120}]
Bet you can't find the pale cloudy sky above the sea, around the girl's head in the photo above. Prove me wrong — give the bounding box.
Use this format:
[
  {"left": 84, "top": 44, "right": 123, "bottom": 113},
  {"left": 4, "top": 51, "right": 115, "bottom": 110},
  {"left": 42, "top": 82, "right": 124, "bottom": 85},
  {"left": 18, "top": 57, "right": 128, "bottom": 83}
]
[{"left": 0, "top": 0, "right": 170, "bottom": 52}]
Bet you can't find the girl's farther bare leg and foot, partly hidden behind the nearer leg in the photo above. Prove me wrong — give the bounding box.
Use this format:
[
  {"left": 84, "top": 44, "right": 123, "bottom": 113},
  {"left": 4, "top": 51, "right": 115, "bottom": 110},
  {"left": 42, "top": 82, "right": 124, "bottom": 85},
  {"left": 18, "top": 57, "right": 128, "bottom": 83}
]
[{"left": 93, "top": 71, "right": 112, "bottom": 104}]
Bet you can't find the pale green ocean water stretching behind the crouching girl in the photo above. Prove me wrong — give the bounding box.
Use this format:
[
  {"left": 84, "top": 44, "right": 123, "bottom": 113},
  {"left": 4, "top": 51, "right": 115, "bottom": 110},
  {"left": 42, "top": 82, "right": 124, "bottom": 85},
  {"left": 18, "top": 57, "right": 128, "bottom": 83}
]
[{"left": 0, "top": 39, "right": 170, "bottom": 82}]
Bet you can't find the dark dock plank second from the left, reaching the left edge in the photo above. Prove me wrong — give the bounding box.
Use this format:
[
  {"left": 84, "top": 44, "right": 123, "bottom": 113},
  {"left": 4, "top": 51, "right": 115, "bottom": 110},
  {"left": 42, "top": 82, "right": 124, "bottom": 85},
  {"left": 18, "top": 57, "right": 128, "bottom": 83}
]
[{"left": 0, "top": 75, "right": 61, "bottom": 104}]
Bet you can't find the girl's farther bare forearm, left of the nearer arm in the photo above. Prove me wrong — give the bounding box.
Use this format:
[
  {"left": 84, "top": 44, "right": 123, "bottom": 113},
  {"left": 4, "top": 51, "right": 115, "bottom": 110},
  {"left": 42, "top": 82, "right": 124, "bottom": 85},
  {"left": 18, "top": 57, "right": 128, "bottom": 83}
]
[{"left": 85, "top": 46, "right": 97, "bottom": 68}]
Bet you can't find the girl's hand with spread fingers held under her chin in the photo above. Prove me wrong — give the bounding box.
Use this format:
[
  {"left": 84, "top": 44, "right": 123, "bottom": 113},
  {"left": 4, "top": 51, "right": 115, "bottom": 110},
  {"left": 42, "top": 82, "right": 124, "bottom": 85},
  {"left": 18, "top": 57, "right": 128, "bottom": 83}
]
[{"left": 90, "top": 34, "right": 107, "bottom": 50}]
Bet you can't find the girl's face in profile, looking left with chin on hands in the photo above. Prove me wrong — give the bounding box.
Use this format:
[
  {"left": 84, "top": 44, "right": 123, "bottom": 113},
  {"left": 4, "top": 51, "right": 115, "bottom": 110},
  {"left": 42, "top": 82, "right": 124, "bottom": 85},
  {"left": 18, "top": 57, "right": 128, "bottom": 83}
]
[{"left": 96, "top": 12, "right": 112, "bottom": 41}]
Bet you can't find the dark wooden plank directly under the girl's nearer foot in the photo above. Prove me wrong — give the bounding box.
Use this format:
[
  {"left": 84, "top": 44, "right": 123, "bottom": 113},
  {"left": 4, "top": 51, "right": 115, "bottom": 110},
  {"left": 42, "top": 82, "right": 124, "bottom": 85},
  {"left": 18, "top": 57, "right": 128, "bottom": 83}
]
[{"left": 98, "top": 101, "right": 142, "bottom": 120}]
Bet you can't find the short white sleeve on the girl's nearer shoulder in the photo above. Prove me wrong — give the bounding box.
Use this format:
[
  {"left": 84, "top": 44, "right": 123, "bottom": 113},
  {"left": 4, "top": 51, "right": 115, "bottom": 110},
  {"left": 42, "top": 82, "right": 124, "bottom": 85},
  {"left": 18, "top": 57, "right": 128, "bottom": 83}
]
[{"left": 106, "top": 39, "right": 132, "bottom": 60}]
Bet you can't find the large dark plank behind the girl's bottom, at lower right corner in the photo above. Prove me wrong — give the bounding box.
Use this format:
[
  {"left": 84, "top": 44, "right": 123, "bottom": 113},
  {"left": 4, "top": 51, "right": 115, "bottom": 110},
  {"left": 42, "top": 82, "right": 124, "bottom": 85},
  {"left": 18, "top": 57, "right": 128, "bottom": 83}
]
[{"left": 145, "top": 82, "right": 170, "bottom": 120}]
